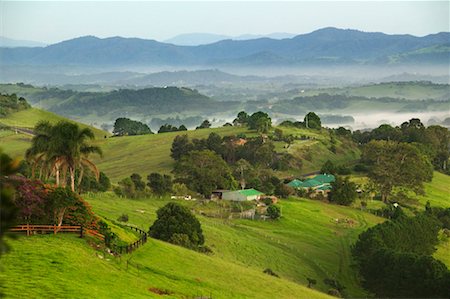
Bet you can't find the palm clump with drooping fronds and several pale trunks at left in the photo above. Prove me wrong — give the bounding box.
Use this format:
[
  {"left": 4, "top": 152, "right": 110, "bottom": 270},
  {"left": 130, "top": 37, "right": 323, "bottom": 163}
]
[{"left": 27, "top": 121, "right": 102, "bottom": 191}]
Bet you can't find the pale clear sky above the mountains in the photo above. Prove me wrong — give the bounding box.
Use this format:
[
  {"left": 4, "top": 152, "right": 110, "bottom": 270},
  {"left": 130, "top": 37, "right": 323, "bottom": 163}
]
[{"left": 0, "top": 0, "right": 450, "bottom": 43}]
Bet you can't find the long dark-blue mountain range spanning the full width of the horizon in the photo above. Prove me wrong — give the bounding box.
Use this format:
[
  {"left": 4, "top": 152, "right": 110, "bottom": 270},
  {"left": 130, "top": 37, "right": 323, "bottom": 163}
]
[{"left": 0, "top": 28, "right": 450, "bottom": 67}]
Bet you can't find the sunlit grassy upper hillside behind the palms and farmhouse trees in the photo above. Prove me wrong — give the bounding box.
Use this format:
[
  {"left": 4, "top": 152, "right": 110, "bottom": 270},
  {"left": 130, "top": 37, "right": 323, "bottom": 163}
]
[{"left": 0, "top": 108, "right": 359, "bottom": 182}]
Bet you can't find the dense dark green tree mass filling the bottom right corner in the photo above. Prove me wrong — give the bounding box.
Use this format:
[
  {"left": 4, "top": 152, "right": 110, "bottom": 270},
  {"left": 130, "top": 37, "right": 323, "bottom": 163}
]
[{"left": 352, "top": 209, "right": 450, "bottom": 298}]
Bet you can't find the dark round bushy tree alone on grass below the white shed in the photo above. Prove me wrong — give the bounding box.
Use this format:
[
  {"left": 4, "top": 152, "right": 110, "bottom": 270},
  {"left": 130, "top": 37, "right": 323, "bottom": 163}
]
[{"left": 150, "top": 202, "right": 205, "bottom": 246}]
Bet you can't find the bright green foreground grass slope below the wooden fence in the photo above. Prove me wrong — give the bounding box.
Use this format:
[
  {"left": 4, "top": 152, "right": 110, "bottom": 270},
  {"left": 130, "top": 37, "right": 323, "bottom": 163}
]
[{"left": 0, "top": 235, "right": 327, "bottom": 298}]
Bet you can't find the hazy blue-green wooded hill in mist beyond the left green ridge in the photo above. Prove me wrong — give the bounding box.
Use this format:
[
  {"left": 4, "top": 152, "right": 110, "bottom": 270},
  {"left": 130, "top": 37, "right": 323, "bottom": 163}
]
[{"left": 0, "top": 84, "right": 239, "bottom": 123}]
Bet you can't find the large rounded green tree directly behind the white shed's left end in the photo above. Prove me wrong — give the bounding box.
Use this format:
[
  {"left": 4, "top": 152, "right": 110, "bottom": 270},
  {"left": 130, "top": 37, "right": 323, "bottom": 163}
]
[{"left": 174, "top": 150, "right": 236, "bottom": 196}]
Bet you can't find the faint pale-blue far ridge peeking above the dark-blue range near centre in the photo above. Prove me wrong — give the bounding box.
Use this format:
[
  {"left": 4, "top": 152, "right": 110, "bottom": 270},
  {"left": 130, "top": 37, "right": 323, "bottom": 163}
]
[{"left": 164, "top": 32, "right": 295, "bottom": 46}]
